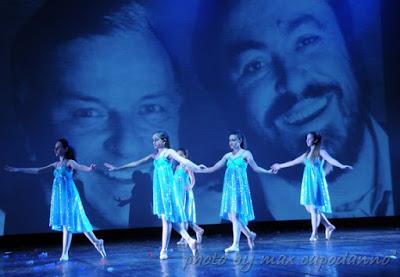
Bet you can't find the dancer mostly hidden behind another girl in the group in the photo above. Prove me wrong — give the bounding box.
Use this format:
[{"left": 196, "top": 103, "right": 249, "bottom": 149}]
[{"left": 174, "top": 148, "right": 204, "bottom": 244}]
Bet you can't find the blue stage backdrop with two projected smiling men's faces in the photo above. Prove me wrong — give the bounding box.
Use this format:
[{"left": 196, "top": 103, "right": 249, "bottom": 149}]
[{"left": 0, "top": 0, "right": 395, "bottom": 234}]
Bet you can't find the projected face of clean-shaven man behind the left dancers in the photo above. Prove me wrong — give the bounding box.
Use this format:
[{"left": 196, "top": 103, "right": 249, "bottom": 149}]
[{"left": 34, "top": 29, "right": 180, "bottom": 227}]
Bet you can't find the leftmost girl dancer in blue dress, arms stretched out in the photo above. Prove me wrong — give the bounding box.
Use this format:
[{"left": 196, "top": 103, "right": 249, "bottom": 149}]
[{"left": 5, "top": 138, "right": 106, "bottom": 261}]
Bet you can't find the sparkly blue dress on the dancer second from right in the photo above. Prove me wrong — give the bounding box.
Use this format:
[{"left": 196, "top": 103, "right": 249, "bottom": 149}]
[{"left": 220, "top": 155, "right": 254, "bottom": 225}]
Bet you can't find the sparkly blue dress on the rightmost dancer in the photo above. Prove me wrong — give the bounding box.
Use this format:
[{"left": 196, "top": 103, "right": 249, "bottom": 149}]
[{"left": 300, "top": 158, "right": 332, "bottom": 213}]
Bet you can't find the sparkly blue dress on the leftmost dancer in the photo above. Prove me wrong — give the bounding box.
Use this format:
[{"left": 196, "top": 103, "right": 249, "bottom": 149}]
[{"left": 49, "top": 165, "right": 93, "bottom": 233}]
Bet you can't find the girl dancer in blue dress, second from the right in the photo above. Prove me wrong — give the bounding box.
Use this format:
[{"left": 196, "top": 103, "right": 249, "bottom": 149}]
[{"left": 201, "top": 132, "right": 272, "bottom": 253}]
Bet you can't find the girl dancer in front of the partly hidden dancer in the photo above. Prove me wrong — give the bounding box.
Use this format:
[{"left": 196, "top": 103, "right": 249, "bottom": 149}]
[{"left": 104, "top": 131, "right": 203, "bottom": 260}]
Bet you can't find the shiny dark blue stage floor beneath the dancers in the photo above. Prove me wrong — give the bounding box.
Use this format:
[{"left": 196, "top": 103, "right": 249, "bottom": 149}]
[{"left": 0, "top": 228, "right": 400, "bottom": 276}]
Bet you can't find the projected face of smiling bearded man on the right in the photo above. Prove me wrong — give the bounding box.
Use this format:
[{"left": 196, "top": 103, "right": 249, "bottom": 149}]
[{"left": 223, "top": 0, "right": 360, "bottom": 155}]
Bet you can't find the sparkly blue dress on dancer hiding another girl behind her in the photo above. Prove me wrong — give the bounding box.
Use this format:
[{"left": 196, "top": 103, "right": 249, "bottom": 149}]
[{"left": 153, "top": 156, "right": 186, "bottom": 223}]
